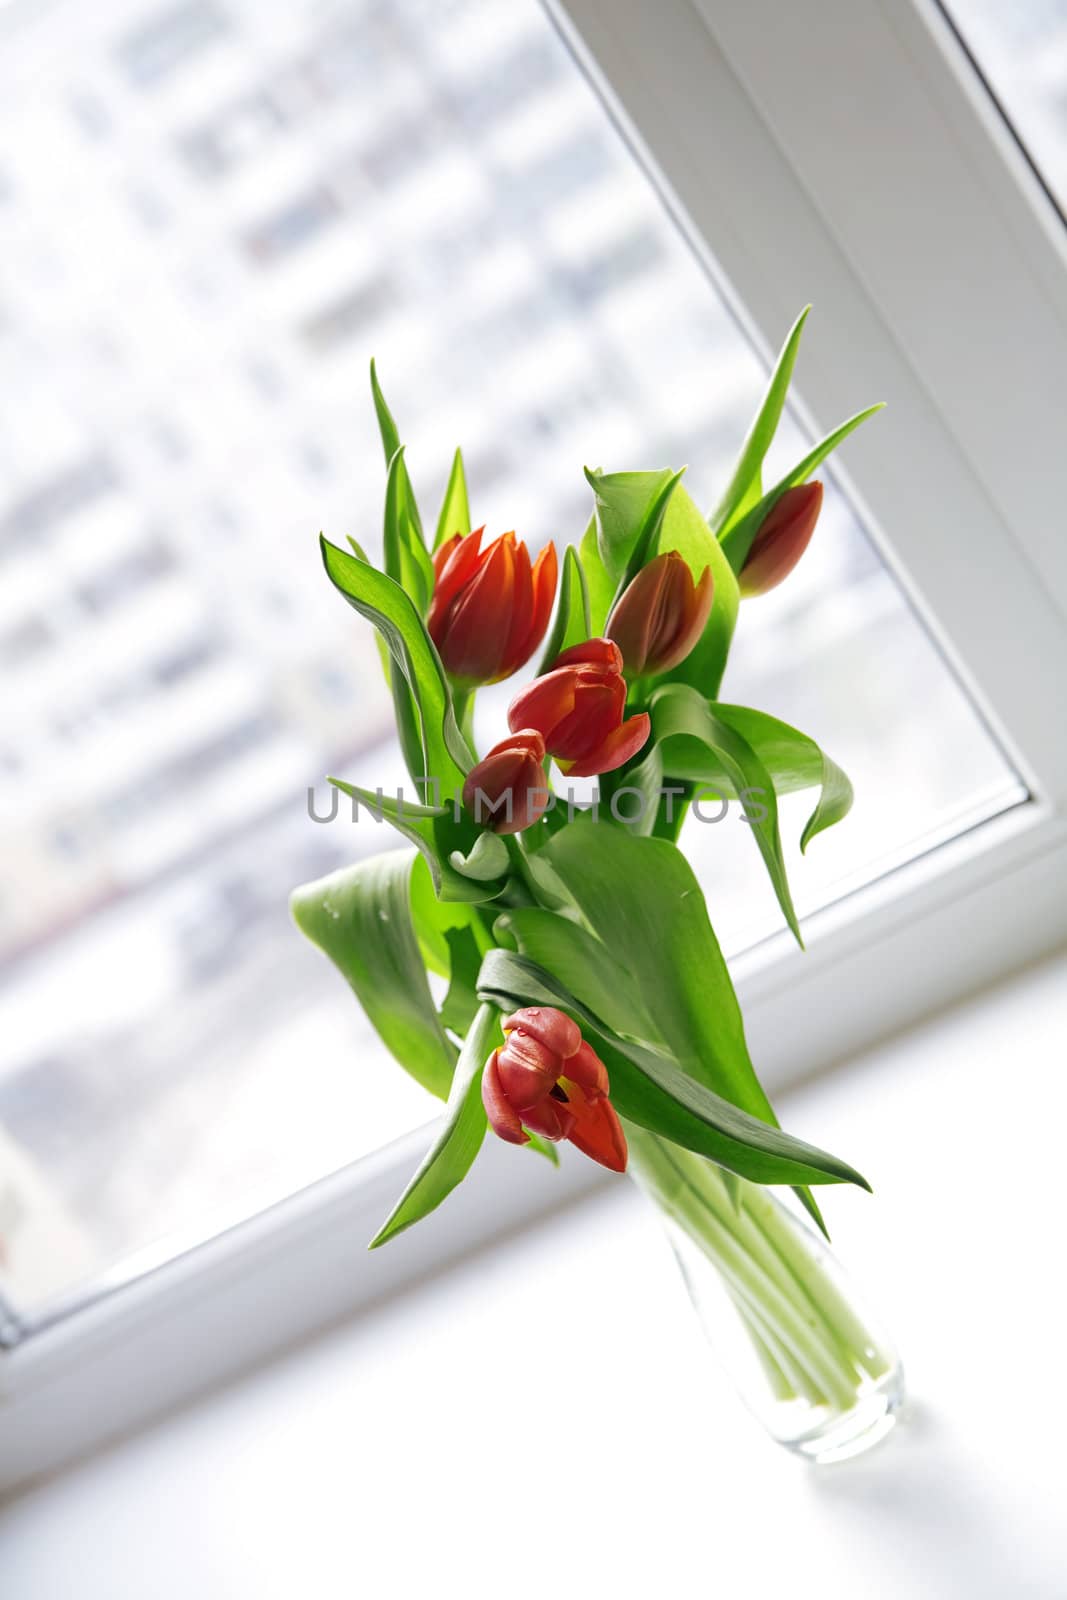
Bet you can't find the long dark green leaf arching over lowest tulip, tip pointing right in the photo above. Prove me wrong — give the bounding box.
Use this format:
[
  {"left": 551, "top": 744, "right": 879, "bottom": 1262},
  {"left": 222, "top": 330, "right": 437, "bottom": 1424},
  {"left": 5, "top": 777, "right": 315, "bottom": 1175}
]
[{"left": 478, "top": 947, "right": 869, "bottom": 1189}]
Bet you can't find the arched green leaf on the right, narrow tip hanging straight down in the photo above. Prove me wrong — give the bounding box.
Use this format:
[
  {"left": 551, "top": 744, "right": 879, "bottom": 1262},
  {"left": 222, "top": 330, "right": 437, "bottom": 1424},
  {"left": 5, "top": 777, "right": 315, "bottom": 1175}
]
[{"left": 651, "top": 683, "right": 803, "bottom": 949}]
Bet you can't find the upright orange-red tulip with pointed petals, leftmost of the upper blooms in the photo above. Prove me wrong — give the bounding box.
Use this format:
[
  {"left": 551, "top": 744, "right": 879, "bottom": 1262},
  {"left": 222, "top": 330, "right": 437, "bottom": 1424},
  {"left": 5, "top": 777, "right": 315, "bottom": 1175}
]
[{"left": 426, "top": 528, "right": 555, "bottom": 688}]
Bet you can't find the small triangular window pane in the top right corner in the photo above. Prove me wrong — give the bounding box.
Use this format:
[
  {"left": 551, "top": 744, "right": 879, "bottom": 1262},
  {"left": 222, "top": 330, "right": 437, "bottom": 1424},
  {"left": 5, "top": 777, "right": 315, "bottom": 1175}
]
[{"left": 945, "top": 0, "right": 1067, "bottom": 214}]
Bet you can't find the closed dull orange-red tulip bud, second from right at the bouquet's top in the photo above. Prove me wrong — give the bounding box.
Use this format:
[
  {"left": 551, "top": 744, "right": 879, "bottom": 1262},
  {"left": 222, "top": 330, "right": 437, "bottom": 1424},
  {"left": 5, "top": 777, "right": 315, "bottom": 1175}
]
[{"left": 605, "top": 550, "right": 713, "bottom": 678}]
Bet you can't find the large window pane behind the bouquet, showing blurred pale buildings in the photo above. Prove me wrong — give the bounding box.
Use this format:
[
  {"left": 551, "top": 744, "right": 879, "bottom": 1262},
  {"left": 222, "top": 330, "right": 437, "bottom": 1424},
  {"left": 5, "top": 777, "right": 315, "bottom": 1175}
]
[{"left": 0, "top": 0, "right": 1021, "bottom": 1310}]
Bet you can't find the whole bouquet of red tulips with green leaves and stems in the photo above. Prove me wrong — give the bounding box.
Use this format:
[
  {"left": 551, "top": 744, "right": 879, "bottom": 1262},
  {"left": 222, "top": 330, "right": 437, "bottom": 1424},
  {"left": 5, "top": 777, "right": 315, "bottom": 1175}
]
[{"left": 293, "top": 314, "right": 894, "bottom": 1453}]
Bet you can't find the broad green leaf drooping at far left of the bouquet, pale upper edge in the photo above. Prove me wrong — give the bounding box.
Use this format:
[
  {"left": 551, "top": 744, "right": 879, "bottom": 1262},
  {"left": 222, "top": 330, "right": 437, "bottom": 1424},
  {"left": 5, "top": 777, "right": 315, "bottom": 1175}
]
[{"left": 290, "top": 850, "right": 456, "bottom": 1099}]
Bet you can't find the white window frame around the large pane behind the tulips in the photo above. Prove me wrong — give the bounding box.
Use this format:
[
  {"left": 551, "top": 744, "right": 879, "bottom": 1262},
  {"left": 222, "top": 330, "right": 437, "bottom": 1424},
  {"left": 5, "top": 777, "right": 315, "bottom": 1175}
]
[{"left": 0, "top": 0, "right": 1067, "bottom": 1491}]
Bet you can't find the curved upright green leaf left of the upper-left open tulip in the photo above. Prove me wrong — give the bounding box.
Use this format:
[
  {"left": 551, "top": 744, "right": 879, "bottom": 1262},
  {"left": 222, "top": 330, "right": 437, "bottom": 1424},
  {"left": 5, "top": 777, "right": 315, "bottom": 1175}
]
[{"left": 320, "top": 536, "right": 474, "bottom": 800}]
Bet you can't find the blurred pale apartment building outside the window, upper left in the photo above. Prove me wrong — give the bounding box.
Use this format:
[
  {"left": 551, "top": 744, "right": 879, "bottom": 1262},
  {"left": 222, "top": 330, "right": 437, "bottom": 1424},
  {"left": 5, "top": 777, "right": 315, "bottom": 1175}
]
[{"left": 0, "top": 0, "right": 777, "bottom": 955}]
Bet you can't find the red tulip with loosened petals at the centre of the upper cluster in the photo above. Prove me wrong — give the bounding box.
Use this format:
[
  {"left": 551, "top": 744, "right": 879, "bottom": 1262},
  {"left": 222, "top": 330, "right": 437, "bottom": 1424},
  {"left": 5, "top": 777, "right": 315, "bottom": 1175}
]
[{"left": 507, "top": 638, "right": 651, "bottom": 778}]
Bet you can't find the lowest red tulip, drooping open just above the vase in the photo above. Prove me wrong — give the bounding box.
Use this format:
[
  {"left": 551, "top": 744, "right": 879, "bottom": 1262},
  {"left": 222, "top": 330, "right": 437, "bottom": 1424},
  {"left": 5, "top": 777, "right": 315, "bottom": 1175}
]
[{"left": 482, "top": 1006, "right": 627, "bottom": 1173}]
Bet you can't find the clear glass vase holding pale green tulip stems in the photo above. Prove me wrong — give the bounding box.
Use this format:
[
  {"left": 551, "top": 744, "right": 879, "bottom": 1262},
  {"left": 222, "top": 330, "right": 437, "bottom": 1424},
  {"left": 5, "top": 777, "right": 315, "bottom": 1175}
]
[{"left": 627, "top": 1126, "right": 904, "bottom": 1462}]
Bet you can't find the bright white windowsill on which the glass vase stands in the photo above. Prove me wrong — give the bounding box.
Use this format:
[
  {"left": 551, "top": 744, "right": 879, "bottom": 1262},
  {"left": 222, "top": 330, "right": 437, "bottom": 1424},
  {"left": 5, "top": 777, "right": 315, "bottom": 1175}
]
[{"left": 0, "top": 933, "right": 1067, "bottom": 1600}]
